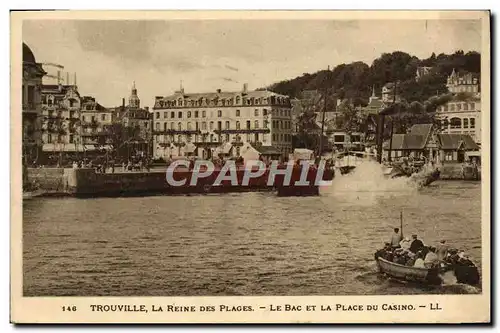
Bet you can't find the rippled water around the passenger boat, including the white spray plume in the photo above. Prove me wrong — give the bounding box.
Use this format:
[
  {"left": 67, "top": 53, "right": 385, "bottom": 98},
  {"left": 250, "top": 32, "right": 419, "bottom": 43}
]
[{"left": 23, "top": 163, "right": 481, "bottom": 296}]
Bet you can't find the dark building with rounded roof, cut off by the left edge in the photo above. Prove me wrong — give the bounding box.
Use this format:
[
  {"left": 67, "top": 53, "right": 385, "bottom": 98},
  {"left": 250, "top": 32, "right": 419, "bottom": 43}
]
[{"left": 21, "top": 43, "right": 46, "bottom": 163}]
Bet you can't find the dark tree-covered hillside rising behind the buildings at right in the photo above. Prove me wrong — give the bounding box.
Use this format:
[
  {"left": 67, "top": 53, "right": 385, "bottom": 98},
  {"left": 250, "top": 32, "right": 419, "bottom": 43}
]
[{"left": 267, "top": 51, "right": 481, "bottom": 105}]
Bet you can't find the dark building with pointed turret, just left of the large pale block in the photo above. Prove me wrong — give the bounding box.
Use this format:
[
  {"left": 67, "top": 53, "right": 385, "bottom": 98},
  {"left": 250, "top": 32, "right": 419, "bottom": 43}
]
[{"left": 115, "top": 82, "right": 153, "bottom": 156}]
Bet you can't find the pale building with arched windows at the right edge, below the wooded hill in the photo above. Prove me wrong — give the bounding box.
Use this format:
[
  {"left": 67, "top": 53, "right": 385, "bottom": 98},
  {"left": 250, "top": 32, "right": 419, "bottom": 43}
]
[{"left": 436, "top": 70, "right": 481, "bottom": 144}]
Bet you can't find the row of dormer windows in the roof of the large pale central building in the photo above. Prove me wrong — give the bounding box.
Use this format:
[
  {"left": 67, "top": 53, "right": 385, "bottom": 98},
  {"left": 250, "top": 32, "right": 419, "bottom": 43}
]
[{"left": 156, "top": 96, "right": 288, "bottom": 108}]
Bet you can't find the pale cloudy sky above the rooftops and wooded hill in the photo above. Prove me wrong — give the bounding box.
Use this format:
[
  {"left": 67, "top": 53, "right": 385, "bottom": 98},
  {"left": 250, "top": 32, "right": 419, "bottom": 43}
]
[{"left": 23, "top": 19, "right": 481, "bottom": 107}]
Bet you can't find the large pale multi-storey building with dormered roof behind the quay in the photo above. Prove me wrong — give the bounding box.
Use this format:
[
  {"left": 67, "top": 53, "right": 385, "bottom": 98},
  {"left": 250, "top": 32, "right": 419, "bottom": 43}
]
[{"left": 153, "top": 84, "right": 293, "bottom": 159}]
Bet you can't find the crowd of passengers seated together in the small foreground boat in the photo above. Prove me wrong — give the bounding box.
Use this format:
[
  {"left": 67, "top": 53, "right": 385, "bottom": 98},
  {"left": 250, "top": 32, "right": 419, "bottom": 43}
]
[{"left": 376, "top": 228, "right": 474, "bottom": 268}]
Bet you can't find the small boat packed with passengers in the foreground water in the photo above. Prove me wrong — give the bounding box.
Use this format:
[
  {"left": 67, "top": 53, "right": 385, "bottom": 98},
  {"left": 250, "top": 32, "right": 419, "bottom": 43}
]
[{"left": 375, "top": 214, "right": 480, "bottom": 285}]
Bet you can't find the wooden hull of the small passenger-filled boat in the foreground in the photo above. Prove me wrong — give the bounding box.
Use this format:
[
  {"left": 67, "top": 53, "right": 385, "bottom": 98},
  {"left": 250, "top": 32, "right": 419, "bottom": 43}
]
[{"left": 375, "top": 253, "right": 442, "bottom": 285}]
